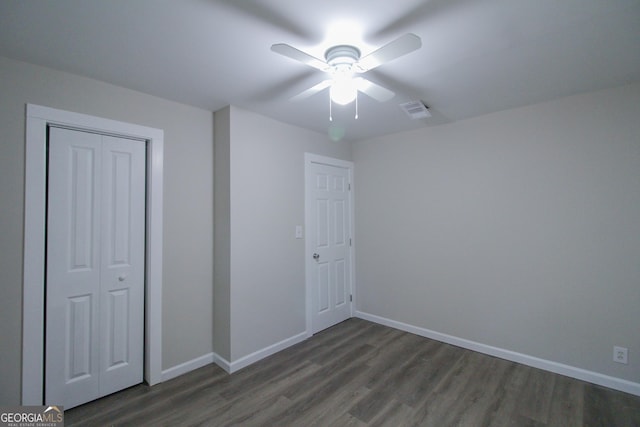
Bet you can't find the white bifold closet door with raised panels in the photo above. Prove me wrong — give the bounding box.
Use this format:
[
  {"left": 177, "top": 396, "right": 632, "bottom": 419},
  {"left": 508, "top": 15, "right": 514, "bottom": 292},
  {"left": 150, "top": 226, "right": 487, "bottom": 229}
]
[{"left": 45, "top": 127, "right": 145, "bottom": 408}]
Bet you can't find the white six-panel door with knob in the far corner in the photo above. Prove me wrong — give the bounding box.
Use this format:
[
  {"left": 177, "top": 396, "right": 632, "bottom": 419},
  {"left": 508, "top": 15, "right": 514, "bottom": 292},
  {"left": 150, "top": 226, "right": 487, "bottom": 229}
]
[{"left": 306, "top": 160, "right": 352, "bottom": 333}]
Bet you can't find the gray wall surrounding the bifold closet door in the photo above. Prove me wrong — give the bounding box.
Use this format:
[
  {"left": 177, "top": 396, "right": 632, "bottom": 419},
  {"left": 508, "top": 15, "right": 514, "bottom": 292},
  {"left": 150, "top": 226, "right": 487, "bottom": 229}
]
[{"left": 0, "top": 57, "right": 213, "bottom": 405}]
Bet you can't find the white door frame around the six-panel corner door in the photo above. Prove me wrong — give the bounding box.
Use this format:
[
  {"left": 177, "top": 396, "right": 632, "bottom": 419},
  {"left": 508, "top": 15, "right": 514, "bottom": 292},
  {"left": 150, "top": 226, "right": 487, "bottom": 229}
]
[{"left": 304, "top": 153, "right": 356, "bottom": 338}]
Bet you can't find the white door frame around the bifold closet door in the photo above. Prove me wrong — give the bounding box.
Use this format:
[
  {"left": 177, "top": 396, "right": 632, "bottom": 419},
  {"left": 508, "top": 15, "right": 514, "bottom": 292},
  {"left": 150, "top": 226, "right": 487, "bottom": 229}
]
[{"left": 22, "top": 104, "right": 164, "bottom": 405}]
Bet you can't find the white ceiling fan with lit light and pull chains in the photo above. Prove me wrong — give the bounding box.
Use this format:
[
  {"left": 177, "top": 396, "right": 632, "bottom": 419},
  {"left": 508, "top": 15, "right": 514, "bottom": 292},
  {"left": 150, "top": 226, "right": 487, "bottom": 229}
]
[{"left": 271, "top": 33, "right": 422, "bottom": 110}]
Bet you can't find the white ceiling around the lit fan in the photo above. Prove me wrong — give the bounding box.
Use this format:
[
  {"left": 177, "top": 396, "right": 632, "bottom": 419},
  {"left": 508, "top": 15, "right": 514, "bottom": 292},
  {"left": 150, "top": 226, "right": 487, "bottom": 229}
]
[{"left": 0, "top": 0, "right": 640, "bottom": 140}]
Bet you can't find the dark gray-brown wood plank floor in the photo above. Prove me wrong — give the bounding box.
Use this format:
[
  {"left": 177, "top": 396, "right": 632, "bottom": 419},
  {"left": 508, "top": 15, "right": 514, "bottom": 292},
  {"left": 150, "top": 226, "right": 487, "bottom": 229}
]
[{"left": 65, "top": 319, "right": 640, "bottom": 427}]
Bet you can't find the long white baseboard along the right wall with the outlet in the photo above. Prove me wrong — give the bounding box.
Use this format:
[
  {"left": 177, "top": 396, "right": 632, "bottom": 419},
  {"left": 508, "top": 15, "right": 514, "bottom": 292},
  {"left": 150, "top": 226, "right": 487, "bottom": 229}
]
[{"left": 355, "top": 311, "right": 640, "bottom": 396}]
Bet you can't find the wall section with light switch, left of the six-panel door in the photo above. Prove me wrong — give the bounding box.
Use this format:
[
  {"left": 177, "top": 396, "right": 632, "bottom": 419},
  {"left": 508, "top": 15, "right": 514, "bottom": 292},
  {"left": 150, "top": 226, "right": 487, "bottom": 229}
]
[{"left": 214, "top": 107, "right": 351, "bottom": 363}]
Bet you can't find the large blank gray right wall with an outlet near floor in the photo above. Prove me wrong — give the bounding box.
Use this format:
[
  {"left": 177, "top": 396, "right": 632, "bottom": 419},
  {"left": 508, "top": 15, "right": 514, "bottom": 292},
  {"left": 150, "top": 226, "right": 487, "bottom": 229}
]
[{"left": 353, "top": 85, "right": 640, "bottom": 382}]
